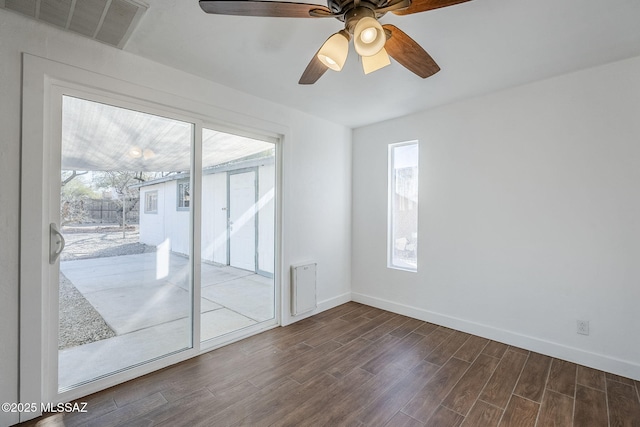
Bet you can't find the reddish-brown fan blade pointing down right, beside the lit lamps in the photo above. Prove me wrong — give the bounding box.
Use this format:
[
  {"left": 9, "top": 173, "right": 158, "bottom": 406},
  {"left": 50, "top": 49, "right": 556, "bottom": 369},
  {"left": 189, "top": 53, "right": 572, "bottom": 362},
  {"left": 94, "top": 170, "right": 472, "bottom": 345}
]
[{"left": 382, "top": 24, "right": 440, "bottom": 79}]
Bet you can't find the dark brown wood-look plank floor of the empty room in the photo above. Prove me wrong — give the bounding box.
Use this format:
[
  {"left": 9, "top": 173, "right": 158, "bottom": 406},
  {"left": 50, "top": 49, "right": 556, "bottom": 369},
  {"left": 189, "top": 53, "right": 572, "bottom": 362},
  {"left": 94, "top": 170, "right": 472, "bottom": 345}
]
[{"left": 17, "top": 303, "right": 640, "bottom": 427}]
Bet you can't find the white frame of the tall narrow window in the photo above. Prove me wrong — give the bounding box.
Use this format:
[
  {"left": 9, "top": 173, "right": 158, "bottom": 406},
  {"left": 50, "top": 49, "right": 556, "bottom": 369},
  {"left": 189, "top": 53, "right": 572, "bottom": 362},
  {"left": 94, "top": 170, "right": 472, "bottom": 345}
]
[{"left": 387, "top": 140, "right": 420, "bottom": 273}]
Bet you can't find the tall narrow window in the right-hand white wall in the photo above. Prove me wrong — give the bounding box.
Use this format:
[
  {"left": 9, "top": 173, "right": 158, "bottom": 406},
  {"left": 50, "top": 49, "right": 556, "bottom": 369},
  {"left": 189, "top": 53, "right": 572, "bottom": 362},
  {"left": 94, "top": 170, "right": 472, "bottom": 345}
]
[{"left": 388, "top": 141, "right": 418, "bottom": 271}]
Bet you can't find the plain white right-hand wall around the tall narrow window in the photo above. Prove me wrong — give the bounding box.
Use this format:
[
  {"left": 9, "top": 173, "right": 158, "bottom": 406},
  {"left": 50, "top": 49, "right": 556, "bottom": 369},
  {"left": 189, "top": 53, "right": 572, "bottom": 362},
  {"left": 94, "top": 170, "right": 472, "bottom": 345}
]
[{"left": 352, "top": 58, "right": 640, "bottom": 379}]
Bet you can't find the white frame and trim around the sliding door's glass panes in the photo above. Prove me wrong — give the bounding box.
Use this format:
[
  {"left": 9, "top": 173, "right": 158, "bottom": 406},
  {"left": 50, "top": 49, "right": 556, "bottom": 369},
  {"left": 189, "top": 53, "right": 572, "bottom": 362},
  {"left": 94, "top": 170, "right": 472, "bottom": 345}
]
[{"left": 19, "top": 54, "right": 288, "bottom": 422}]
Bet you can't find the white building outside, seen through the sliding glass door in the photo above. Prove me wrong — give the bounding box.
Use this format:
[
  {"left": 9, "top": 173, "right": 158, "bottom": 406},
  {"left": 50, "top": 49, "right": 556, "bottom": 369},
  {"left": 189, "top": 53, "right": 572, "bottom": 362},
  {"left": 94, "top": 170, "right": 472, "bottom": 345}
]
[{"left": 138, "top": 155, "right": 275, "bottom": 277}]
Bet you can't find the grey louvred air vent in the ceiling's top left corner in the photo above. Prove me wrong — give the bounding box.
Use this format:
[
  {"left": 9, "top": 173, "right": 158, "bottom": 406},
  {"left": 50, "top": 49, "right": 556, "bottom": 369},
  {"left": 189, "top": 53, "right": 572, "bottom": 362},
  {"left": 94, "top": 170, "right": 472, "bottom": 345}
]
[{"left": 0, "top": 0, "right": 149, "bottom": 49}]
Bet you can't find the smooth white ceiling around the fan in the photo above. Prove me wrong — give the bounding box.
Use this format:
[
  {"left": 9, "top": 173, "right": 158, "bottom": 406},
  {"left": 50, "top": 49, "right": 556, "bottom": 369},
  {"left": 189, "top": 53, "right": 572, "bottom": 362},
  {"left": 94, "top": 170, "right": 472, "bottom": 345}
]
[{"left": 124, "top": 0, "right": 640, "bottom": 127}]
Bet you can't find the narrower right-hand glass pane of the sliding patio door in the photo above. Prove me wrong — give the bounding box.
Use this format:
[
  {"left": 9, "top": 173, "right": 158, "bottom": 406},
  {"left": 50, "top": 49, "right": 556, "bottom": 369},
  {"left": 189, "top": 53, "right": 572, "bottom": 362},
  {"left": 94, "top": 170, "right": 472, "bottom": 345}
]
[{"left": 200, "top": 128, "right": 276, "bottom": 342}]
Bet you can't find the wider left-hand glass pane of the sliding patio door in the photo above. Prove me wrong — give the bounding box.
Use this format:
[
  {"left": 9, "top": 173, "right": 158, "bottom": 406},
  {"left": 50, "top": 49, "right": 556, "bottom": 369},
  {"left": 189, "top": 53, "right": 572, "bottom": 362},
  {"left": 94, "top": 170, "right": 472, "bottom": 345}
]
[{"left": 55, "top": 96, "right": 195, "bottom": 392}]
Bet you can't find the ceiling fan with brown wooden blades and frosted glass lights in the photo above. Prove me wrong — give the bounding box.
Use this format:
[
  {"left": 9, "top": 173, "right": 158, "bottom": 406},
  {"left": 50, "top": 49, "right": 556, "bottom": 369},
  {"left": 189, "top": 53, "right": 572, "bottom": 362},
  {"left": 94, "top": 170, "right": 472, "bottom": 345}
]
[{"left": 200, "top": 0, "right": 470, "bottom": 84}]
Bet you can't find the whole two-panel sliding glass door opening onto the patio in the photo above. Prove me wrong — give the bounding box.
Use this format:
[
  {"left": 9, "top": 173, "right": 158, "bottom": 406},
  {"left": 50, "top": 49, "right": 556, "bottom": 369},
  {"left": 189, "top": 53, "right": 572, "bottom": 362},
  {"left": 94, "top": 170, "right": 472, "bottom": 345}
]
[{"left": 43, "top": 88, "right": 277, "bottom": 401}]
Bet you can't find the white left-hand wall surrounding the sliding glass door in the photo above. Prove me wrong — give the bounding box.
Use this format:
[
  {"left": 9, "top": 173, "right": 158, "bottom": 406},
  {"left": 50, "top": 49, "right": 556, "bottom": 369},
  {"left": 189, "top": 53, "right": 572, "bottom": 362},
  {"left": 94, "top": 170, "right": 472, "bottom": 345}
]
[{"left": 0, "top": 10, "right": 351, "bottom": 425}]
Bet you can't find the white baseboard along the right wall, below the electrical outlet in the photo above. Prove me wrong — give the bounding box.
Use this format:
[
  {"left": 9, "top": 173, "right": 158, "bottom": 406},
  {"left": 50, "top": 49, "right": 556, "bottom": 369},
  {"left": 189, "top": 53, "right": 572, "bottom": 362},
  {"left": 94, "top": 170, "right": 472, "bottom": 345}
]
[{"left": 351, "top": 292, "right": 640, "bottom": 381}]
